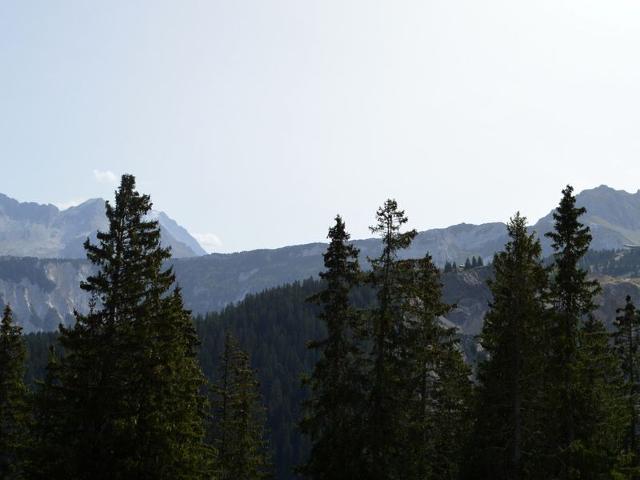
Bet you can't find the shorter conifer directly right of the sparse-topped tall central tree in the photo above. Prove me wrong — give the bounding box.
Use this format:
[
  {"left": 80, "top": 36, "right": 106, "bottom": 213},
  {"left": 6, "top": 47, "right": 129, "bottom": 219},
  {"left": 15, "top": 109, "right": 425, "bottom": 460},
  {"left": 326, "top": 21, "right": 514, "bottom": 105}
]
[{"left": 396, "top": 255, "right": 471, "bottom": 479}]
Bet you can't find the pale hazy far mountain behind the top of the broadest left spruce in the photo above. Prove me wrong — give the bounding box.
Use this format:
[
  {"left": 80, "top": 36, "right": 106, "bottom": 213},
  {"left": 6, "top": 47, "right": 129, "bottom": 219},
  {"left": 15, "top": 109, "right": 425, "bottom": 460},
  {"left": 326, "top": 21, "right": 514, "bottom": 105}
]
[{"left": 0, "top": 194, "right": 206, "bottom": 258}]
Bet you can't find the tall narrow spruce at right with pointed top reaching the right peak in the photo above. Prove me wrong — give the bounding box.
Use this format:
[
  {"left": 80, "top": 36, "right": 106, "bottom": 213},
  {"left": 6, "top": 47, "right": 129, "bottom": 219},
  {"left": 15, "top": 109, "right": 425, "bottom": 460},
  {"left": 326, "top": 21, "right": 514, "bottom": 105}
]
[{"left": 546, "top": 185, "right": 600, "bottom": 479}]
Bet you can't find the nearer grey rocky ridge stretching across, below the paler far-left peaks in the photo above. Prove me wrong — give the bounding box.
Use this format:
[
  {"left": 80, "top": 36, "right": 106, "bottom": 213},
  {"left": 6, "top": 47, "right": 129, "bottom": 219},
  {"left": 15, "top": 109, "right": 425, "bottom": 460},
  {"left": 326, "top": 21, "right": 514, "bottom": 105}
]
[{"left": 0, "top": 186, "right": 640, "bottom": 331}]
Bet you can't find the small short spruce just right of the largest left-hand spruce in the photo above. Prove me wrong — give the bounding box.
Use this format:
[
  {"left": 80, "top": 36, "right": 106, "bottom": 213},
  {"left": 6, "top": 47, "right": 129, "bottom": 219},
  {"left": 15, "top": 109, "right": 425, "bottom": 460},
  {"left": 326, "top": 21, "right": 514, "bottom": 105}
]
[{"left": 211, "top": 333, "right": 271, "bottom": 480}]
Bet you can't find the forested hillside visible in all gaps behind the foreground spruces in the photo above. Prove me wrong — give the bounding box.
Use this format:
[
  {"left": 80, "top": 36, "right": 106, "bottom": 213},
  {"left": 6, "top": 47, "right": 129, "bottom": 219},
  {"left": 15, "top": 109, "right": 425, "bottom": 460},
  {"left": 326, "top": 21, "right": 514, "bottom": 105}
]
[{"left": 25, "top": 264, "right": 640, "bottom": 479}]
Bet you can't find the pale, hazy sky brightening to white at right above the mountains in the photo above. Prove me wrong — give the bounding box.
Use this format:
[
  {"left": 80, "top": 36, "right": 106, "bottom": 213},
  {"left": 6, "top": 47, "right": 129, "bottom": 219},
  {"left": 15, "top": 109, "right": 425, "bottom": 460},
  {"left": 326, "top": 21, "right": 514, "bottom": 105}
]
[{"left": 0, "top": 0, "right": 640, "bottom": 252}]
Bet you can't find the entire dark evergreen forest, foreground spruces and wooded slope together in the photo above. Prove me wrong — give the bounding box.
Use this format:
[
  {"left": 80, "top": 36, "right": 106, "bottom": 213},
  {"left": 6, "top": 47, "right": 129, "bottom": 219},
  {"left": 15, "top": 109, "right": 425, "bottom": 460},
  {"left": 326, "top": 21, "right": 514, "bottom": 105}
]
[{"left": 0, "top": 175, "right": 640, "bottom": 480}]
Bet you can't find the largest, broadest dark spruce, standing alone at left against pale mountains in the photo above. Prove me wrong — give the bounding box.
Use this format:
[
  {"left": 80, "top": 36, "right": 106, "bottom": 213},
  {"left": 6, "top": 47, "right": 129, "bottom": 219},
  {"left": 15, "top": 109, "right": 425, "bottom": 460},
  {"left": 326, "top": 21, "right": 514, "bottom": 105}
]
[{"left": 36, "top": 175, "right": 208, "bottom": 479}]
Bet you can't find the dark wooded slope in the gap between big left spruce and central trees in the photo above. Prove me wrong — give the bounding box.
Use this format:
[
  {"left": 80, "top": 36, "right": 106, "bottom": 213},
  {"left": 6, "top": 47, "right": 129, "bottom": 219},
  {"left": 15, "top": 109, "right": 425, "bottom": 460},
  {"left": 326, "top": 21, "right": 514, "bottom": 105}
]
[{"left": 196, "top": 279, "right": 330, "bottom": 480}]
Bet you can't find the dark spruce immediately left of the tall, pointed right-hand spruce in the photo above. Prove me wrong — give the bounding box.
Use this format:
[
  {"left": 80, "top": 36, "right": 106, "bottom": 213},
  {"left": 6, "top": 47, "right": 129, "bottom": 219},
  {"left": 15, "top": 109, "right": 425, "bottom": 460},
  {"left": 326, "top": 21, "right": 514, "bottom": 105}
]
[{"left": 466, "top": 213, "right": 547, "bottom": 480}]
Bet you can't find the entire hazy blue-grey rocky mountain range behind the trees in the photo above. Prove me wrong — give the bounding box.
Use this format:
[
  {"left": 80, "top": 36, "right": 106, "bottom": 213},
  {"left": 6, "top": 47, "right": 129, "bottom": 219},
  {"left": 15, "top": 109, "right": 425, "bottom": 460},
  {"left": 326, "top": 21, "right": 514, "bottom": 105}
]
[{"left": 0, "top": 186, "right": 640, "bottom": 333}]
